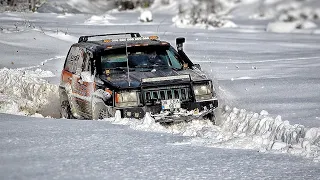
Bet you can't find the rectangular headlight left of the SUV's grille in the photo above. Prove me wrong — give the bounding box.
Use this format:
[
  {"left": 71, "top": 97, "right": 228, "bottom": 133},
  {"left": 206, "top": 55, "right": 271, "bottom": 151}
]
[{"left": 116, "top": 91, "right": 138, "bottom": 107}]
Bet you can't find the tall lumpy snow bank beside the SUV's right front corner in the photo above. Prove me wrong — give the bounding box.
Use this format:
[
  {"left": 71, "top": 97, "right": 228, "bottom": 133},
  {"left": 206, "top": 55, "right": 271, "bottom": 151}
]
[{"left": 221, "top": 106, "right": 320, "bottom": 161}]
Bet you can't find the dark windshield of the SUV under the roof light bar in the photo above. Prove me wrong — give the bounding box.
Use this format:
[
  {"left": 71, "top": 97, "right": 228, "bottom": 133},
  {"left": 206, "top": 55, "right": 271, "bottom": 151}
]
[{"left": 101, "top": 46, "right": 183, "bottom": 71}]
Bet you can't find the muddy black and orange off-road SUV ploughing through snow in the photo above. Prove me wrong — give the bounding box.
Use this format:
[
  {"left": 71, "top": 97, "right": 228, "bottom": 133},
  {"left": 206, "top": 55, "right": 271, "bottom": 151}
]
[{"left": 59, "top": 33, "right": 218, "bottom": 122}]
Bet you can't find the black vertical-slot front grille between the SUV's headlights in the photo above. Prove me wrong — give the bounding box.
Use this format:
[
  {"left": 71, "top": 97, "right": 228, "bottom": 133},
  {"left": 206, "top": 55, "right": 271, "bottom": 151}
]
[{"left": 142, "top": 86, "right": 191, "bottom": 104}]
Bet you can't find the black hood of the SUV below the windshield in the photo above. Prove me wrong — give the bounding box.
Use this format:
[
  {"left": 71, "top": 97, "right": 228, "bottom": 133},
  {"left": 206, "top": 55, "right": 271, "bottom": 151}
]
[{"left": 101, "top": 69, "right": 208, "bottom": 89}]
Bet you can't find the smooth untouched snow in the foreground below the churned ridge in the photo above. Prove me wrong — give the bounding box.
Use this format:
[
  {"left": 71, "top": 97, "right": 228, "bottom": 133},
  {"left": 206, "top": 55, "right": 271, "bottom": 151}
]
[{"left": 0, "top": 114, "right": 319, "bottom": 179}]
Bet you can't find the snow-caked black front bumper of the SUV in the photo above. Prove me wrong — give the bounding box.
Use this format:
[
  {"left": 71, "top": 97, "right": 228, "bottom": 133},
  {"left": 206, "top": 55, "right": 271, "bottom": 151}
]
[{"left": 116, "top": 99, "right": 218, "bottom": 122}]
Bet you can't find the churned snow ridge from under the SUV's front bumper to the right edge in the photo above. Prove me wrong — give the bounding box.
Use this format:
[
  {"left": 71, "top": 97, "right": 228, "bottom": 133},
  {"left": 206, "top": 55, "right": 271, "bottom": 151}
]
[{"left": 104, "top": 106, "right": 320, "bottom": 162}]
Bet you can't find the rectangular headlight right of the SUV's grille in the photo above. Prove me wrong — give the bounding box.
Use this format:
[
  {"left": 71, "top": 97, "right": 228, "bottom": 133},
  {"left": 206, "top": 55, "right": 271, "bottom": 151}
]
[{"left": 193, "top": 82, "right": 213, "bottom": 101}]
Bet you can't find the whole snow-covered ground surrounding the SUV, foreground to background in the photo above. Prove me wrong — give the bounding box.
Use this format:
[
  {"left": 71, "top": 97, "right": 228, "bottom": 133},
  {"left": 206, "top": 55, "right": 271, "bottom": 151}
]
[{"left": 0, "top": 1, "right": 320, "bottom": 179}]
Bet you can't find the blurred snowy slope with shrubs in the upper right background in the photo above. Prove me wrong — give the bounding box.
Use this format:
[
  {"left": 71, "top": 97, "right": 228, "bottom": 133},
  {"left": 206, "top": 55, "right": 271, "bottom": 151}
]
[{"left": 173, "top": 0, "right": 320, "bottom": 33}]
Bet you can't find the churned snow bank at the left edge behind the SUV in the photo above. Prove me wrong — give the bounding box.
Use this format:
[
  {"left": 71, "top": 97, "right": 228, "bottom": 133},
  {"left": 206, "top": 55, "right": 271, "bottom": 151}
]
[{"left": 0, "top": 68, "right": 59, "bottom": 117}]
